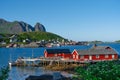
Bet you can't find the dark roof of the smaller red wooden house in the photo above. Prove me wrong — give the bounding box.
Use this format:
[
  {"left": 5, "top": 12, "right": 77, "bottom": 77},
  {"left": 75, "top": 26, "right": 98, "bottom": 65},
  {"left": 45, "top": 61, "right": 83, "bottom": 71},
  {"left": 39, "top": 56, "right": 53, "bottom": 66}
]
[{"left": 46, "top": 49, "right": 71, "bottom": 54}]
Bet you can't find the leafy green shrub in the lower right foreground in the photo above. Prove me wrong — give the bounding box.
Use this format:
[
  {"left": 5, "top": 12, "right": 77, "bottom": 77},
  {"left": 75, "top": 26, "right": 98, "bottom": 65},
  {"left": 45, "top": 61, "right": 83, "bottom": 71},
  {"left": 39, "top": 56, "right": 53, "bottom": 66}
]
[{"left": 76, "top": 61, "right": 120, "bottom": 80}]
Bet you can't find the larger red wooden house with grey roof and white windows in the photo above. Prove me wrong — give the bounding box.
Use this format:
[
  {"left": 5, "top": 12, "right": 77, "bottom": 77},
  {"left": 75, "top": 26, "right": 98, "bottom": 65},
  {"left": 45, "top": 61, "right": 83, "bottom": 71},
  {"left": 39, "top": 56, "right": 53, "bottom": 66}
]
[{"left": 72, "top": 46, "right": 118, "bottom": 61}]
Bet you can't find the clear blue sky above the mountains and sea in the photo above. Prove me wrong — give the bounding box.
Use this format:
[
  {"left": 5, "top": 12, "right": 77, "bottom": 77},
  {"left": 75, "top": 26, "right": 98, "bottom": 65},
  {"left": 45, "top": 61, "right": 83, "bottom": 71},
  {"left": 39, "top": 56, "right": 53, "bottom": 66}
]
[{"left": 0, "top": 0, "right": 120, "bottom": 41}]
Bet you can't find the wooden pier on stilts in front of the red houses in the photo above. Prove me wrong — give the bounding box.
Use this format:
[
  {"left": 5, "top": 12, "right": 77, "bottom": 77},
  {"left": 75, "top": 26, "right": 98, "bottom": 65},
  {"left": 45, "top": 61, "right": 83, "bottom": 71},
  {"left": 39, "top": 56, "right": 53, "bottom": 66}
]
[{"left": 9, "top": 57, "right": 88, "bottom": 67}]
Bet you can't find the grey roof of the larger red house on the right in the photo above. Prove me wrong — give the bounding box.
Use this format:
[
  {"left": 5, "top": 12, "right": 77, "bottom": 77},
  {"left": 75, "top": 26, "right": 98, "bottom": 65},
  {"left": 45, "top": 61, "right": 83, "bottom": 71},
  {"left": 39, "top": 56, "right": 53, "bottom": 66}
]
[{"left": 77, "top": 46, "right": 117, "bottom": 55}]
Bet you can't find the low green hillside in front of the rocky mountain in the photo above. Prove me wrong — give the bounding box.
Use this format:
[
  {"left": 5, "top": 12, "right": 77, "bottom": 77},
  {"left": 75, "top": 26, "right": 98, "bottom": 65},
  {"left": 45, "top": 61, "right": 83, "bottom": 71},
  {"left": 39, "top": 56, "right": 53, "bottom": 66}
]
[{"left": 18, "top": 31, "right": 64, "bottom": 41}]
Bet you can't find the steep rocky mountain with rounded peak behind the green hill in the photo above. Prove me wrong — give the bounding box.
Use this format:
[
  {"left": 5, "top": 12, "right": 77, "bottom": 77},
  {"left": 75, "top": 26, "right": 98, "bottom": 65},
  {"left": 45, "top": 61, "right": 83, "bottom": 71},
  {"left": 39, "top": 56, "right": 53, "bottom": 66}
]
[{"left": 0, "top": 19, "right": 46, "bottom": 34}]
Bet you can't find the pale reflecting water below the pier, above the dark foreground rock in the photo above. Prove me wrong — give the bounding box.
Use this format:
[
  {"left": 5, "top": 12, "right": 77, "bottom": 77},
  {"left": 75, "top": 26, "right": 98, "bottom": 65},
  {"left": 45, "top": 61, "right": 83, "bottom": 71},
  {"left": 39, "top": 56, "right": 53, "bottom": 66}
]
[{"left": 8, "top": 67, "right": 51, "bottom": 80}]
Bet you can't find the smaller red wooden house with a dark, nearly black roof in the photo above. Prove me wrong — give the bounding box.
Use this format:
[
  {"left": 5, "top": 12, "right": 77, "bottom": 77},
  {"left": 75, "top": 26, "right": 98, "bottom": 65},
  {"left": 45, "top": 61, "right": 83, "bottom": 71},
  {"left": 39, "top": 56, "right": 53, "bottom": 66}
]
[{"left": 44, "top": 49, "right": 72, "bottom": 59}]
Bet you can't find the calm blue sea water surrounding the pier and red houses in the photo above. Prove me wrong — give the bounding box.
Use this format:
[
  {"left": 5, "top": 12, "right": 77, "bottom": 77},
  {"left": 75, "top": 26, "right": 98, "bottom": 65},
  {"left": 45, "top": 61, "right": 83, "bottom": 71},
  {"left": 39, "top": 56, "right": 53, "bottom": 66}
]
[{"left": 0, "top": 43, "right": 120, "bottom": 80}]
